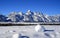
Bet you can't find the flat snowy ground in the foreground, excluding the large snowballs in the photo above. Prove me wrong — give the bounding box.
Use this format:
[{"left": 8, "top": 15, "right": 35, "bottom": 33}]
[{"left": 0, "top": 25, "right": 60, "bottom": 38}]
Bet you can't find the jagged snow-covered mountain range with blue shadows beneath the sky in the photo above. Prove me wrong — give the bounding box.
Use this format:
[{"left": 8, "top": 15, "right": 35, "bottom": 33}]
[{"left": 0, "top": 10, "right": 60, "bottom": 22}]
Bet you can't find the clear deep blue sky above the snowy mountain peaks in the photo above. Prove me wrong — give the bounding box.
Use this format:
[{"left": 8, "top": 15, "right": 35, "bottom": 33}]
[{"left": 0, "top": 0, "right": 60, "bottom": 15}]
